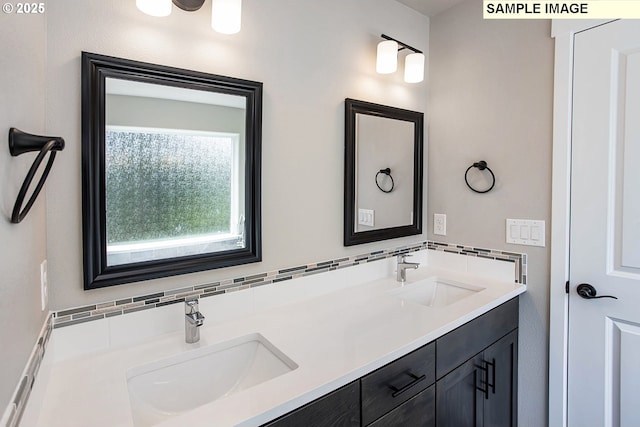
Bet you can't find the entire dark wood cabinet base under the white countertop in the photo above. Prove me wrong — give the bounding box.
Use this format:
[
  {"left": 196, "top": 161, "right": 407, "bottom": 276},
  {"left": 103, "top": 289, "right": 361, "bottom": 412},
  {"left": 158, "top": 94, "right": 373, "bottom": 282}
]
[{"left": 263, "top": 298, "right": 518, "bottom": 427}]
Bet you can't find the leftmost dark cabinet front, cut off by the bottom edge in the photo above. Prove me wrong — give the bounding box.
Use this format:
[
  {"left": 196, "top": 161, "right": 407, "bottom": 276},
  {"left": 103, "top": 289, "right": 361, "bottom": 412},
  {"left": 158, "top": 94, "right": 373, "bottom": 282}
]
[{"left": 263, "top": 381, "right": 360, "bottom": 427}]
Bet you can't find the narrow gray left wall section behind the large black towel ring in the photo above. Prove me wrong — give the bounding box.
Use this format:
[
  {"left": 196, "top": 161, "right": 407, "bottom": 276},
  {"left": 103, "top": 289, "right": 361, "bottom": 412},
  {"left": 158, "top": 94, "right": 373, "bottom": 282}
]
[{"left": 0, "top": 13, "right": 48, "bottom": 408}]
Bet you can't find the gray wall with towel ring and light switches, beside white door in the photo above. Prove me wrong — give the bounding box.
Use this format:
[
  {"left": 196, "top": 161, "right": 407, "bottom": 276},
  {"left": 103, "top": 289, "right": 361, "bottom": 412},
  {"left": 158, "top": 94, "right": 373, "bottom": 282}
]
[{"left": 428, "top": 0, "right": 553, "bottom": 427}]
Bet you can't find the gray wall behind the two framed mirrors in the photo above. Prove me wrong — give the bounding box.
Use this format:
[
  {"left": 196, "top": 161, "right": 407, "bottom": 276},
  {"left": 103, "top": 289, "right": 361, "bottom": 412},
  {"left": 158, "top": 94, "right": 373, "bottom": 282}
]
[{"left": 46, "top": 0, "right": 429, "bottom": 310}]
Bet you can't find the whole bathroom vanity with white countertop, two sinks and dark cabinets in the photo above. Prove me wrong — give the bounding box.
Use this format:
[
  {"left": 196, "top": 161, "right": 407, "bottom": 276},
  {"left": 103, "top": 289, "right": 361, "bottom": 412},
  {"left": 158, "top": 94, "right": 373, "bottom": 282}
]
[{"left": 22, "top": 251, "right": 526, "bottom": 427}]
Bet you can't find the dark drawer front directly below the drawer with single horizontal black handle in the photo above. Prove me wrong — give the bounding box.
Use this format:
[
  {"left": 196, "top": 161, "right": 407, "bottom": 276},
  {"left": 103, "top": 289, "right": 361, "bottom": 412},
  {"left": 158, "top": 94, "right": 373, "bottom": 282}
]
[{"left": 369, "top": 385, "right": 436, "bottom": 427}]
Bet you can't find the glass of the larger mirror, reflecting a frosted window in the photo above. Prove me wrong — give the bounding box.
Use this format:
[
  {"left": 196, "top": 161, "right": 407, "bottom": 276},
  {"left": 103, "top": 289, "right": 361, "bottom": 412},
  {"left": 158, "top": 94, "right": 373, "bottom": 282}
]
[{"left": 105, "top": 78, "right": 245, "bottom": 266}]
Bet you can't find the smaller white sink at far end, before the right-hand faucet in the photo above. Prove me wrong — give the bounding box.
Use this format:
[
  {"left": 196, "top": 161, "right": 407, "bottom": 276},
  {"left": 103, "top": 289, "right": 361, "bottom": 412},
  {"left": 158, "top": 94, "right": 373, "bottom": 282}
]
[{"left": 388, "top": 277, "right": 485, "bottom": 307}]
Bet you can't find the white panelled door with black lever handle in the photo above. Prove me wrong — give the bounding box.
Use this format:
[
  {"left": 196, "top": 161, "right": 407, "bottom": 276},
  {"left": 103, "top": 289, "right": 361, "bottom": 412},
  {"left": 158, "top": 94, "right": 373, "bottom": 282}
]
[{"left": 568, "top": 20, "right": 640, "bottom": 427}]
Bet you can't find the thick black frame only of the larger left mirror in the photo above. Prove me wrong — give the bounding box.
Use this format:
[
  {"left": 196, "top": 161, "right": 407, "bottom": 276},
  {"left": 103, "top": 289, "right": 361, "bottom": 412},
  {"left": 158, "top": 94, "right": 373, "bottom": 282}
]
[{"left": 82, "top": 52, "right": 262, "bottom": 290}]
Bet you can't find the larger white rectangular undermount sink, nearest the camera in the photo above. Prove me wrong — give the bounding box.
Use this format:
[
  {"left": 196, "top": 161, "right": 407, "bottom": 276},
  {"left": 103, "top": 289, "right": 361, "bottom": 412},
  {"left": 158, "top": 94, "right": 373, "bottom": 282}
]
[{"left": 127, "top": 333, "right": 298, "bottom": 427}]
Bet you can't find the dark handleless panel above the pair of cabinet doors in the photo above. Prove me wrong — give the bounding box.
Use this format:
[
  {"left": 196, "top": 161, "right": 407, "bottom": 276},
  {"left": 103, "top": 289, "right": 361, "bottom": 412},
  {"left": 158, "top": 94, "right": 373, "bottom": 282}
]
[{"left": 436, "top": 297, "right": 518, "bottom": 379}]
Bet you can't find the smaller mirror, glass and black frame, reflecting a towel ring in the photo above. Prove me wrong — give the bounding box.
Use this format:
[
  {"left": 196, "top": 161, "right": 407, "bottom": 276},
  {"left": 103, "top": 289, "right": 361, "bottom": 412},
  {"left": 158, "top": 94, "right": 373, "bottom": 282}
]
[{"left": 344, "top": 99, "right": 424, "bottom": 246}]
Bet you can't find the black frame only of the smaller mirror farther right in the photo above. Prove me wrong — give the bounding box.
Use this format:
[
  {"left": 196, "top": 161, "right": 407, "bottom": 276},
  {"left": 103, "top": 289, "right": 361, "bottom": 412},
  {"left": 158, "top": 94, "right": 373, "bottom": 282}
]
[{"left": 344, "top": 98, "right": 424, "bottom": 246}]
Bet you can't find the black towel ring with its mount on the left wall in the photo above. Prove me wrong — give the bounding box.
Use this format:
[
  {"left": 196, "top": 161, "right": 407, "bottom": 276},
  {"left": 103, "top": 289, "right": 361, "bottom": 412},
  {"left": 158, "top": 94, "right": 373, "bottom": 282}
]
[{"left": 9, "top": 128, "right": 64, "bottom": 224}]
